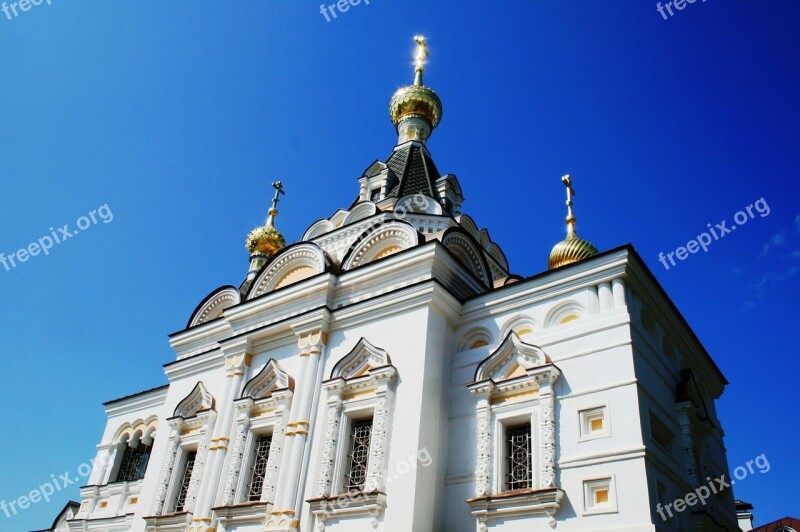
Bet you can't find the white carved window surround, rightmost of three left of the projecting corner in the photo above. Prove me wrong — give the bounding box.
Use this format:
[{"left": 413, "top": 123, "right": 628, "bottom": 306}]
[{"left": 307, "top": 338, "right": 397, "bottom": 530}]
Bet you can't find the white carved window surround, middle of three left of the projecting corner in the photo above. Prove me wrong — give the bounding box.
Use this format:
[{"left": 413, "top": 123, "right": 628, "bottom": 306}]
[{"left": 215, "top": 359, "right": 294, "bottom": 518}]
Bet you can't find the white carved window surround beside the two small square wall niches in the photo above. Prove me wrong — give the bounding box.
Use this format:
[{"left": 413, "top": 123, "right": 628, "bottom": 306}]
[{"left": 466, "top": 331, "right": 564, "bottom": 532}]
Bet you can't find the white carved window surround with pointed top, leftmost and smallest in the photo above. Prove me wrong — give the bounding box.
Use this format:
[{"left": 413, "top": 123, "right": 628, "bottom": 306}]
[{"left": 146, "top": 382, "right": 217, "bottom": 527}]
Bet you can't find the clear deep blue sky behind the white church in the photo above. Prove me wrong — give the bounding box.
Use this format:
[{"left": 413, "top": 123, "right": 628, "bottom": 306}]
[{"left": 0, "top": 0, "right": 800, "bottom": 531}]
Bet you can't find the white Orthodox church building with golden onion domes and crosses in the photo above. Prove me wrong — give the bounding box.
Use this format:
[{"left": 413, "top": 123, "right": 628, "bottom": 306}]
[{"left": 60, "top": 37, "right": 739, "bottom": 532}]
